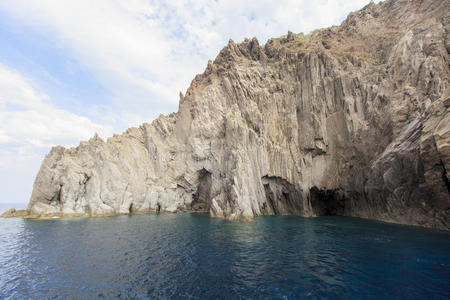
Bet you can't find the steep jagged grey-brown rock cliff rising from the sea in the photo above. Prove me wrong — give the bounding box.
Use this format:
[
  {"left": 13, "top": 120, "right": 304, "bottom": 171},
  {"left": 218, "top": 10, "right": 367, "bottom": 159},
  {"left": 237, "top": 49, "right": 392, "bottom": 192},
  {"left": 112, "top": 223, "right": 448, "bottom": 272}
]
[{"left": 19, "top": 0, "right": 450, "bottom": 229}]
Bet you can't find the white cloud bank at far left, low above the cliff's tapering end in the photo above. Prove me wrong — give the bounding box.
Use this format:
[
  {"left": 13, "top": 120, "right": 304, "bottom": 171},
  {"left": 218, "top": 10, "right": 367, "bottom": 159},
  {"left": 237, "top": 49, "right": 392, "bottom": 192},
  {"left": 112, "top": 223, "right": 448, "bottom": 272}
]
[{"left": 0, "top": 64, "right": 112, "bottom": 168}]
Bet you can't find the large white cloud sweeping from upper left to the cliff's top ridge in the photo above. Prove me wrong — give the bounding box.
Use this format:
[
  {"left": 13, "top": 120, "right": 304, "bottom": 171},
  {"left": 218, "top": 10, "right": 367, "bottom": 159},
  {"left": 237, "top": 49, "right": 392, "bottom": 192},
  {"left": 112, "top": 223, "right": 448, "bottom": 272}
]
[{"left": 0, "top": 0, "right": 376, "bottom": 127}]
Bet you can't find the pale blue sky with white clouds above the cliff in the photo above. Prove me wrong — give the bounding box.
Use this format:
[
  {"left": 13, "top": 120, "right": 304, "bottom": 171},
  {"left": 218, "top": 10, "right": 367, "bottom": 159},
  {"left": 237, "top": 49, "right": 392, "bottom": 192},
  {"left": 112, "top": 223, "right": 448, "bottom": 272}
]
[{"left": 0, "top": 0, "right": 378, "bottom": 203}]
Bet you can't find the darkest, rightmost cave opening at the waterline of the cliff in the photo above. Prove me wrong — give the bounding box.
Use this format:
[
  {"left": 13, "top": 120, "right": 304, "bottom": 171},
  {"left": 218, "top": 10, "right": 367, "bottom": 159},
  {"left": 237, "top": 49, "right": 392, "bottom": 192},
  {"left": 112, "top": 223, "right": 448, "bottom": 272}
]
[{"left": 309, "top": 186, "right": 345, "bottom": 216}]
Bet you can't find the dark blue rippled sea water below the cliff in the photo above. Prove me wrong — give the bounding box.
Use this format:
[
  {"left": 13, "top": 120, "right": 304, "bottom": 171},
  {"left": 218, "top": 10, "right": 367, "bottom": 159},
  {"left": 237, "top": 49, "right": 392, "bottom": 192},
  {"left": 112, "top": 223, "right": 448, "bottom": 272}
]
[{"left": 0, "top": 214, "right": 450, "bottom": 299}]
